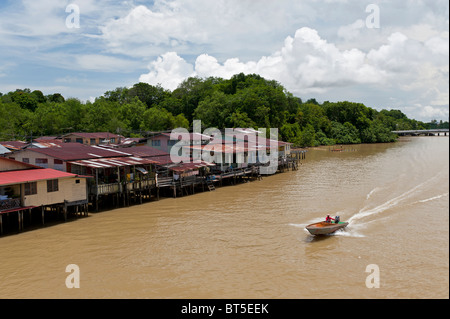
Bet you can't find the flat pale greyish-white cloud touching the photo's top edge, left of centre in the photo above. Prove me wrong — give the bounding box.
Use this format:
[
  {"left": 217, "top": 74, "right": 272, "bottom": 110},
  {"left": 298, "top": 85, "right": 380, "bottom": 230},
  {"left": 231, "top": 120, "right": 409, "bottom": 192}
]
[{"left": 100, "top": 0, "right": 315, "bottom": 57}]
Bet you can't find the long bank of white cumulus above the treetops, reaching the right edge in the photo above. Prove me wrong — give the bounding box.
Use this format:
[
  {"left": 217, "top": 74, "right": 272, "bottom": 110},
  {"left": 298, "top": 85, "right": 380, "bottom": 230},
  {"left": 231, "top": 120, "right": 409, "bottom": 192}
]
[{"left": 140, "top": 24, "right": 449, "bottom": 122}]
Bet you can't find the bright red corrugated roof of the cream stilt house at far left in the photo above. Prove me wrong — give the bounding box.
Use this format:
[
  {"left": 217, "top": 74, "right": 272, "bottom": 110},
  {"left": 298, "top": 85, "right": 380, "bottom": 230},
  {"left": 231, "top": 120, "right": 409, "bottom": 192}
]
[{"left": 0, "top": 168, "right": 78, "bottom": 186}]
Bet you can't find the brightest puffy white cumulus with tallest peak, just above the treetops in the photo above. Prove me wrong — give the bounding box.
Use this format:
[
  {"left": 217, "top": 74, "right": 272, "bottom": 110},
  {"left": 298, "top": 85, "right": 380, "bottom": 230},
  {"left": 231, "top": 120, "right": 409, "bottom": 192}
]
[{"left": 141, "top": 28, "right": 385, "bottom": 94}]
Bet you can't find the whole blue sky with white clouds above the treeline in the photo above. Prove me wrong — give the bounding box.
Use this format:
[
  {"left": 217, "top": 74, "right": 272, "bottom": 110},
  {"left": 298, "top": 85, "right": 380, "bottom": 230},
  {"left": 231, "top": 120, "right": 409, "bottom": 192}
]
[{"left": 0, "top": 0, "right": 449, "bottom": 122}]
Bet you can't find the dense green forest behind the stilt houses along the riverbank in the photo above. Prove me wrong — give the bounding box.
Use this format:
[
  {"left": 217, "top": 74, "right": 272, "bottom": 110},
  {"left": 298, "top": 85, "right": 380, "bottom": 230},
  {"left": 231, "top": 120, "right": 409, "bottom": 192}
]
[{"left": 0, "top": 73, "right": 448, "bottom": 147}]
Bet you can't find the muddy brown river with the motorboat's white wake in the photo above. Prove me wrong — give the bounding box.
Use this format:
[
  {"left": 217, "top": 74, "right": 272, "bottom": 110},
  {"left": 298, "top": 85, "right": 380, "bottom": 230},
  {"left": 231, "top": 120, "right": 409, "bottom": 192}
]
[{"left": 0, "top": 137, "right": 449, "bottom": 299}]
